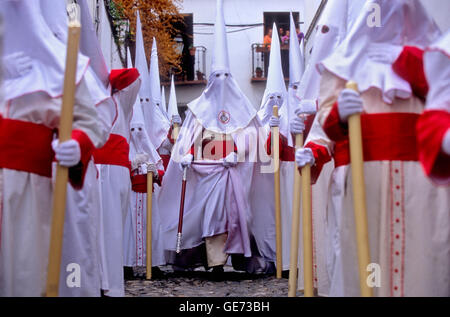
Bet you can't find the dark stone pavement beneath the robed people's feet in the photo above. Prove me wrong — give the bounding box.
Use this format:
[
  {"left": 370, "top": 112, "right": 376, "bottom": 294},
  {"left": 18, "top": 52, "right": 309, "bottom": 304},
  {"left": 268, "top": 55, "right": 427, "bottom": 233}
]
[{"left": 125, "top": 266, "right": 303, "bottom": 297}]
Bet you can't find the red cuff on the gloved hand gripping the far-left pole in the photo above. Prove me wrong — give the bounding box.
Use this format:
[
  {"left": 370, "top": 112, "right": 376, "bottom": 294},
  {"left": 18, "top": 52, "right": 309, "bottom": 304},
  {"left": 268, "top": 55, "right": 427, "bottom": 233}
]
[{"left": 69, "top": 130, "right": 95, "bottom": 189}]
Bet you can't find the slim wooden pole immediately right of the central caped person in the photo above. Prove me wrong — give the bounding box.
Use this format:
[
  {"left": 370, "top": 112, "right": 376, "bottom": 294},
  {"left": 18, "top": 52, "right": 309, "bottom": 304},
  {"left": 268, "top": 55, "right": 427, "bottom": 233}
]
[{"left": 272, "top": 106, "right": 283, "bottom": 279}]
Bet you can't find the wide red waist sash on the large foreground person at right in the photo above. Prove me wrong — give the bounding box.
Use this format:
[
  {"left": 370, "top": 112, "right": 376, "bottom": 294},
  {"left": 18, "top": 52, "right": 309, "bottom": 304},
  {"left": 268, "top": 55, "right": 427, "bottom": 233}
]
[{"left": 334, "top": 113, "right": 419, "bottom": 167}]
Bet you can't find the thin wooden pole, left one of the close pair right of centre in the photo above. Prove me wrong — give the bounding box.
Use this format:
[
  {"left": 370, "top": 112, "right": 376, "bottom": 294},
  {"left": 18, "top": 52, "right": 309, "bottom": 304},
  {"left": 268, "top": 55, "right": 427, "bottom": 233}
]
[{"left": 288, "top": 134, "right": 303, "bottom": 297}]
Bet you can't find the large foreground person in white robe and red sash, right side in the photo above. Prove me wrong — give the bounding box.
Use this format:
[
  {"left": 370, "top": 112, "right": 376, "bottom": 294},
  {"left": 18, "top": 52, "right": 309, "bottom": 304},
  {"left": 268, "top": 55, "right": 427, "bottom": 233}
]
[{"left": 298, "top": 0, "right": 450, "bottom": 296}]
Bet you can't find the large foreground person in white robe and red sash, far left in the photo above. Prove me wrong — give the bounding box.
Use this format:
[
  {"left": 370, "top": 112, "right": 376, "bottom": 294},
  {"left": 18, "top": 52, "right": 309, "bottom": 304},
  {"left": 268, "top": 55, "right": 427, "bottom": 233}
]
[{"left": 0, "top": 1, "right": 107, "bottom": 296}]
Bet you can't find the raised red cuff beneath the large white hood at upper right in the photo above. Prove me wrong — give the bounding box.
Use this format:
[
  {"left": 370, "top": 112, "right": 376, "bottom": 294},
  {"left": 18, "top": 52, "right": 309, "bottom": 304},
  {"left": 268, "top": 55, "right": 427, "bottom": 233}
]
[{"left": 392, "top": 46, "right": 428, "bottom": 100}]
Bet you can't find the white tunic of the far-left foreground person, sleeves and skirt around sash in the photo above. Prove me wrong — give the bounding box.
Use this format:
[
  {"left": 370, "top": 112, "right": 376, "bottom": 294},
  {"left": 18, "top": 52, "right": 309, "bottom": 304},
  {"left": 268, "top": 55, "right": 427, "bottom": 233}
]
[{"left": 0, "top": 80, "right": 107, "bottom": 296}]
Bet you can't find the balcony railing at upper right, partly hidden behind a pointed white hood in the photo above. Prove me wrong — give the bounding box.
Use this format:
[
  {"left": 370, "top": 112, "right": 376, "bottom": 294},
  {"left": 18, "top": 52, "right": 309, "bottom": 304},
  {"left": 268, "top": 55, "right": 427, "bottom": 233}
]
[{"left": 252, "top": 43, "right": 289, "bottom": 82}]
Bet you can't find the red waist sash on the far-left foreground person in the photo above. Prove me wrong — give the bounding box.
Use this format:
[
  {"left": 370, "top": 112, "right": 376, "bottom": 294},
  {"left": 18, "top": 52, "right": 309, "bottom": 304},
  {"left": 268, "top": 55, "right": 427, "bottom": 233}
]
[{"left": 0, "top": 116, "right": 56, "bottom": 177}]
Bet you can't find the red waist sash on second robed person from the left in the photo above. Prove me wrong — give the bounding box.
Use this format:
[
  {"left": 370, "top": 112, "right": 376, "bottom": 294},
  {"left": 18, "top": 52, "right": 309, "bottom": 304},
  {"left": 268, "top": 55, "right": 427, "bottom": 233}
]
[{"left": 93, "top": 134, "right": 131, "bottom": 169}]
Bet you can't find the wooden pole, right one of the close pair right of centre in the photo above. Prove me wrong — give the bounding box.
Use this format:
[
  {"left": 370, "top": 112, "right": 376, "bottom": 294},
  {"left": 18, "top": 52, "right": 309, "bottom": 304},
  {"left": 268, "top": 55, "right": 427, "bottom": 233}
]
[{"left": 301, "top": 154, "right": 314, "bottom": 297}]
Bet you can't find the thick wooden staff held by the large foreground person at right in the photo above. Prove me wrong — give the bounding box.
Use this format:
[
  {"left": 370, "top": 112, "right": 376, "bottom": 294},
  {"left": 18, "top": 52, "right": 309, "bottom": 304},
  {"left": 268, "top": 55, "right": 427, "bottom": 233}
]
[{"left": 346, "top": 81, "right": 373, "bottom": 297}]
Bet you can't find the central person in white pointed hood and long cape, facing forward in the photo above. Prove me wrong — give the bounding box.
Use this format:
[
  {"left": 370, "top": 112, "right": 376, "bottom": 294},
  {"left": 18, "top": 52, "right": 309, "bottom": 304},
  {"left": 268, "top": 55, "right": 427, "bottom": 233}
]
[{"left": 158, "top": 0, "right": 275, "bottom": 277}]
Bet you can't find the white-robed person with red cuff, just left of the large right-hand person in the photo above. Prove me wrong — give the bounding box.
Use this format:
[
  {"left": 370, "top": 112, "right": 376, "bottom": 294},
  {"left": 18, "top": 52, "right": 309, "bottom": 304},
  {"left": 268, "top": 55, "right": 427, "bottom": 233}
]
[{"left": 291, "top": 0, "right": 370, "bottom": 296}]
